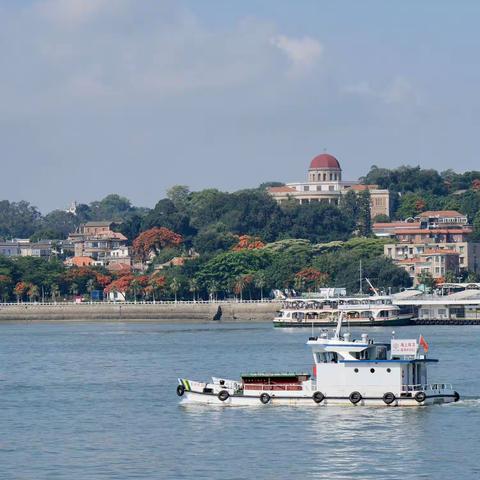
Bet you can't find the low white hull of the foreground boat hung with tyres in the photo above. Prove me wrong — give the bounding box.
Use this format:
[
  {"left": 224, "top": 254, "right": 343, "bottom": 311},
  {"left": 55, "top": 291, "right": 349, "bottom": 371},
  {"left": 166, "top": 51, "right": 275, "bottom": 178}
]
[{"left": 181, "top": 391, "right": 458, "bottom": 407}]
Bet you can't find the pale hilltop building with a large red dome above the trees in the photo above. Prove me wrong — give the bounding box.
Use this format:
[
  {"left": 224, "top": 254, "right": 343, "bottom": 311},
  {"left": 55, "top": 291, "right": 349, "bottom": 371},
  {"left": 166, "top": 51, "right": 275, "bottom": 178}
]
[{"left": 268, "top": 153, "right": 390, "bottom": 218}]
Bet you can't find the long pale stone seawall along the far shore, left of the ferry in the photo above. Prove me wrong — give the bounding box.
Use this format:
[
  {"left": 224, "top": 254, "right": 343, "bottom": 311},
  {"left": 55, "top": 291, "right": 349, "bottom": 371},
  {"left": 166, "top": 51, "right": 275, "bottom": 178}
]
[{"left": 0, "top": 302, "right": 280, "bottom": 323}]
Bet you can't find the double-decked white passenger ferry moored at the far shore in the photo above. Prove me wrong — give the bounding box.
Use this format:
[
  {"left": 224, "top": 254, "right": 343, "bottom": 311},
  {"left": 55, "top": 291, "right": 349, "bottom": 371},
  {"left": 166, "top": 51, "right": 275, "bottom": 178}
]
[{"left": 273, "top": 295, "right": 412, "bottom": 327}]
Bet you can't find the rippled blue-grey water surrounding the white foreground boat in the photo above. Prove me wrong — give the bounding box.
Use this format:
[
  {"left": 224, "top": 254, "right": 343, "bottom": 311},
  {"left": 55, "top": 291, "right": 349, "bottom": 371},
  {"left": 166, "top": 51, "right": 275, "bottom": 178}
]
[{"left": 0, "top": 323, "right": 480, "bottom": 480}]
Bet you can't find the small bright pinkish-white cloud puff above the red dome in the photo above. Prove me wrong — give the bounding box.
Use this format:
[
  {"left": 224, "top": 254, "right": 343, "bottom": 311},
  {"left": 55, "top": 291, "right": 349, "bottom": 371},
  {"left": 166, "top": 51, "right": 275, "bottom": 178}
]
[{"left": 271, "top": 35, "right": 324, "bottom": 74}]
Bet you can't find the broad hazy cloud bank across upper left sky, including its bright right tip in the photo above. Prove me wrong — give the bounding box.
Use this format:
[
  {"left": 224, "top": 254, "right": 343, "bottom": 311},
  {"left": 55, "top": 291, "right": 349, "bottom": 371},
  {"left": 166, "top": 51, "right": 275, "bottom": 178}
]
[{"left": 0, "top": 0, "right": 323, "bottom": 113}]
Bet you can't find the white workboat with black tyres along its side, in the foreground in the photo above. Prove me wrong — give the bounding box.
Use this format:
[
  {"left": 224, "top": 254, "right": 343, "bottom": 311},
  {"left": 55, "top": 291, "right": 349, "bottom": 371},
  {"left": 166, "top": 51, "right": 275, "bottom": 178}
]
[{"left": 177, "top": 315, "right": 460, "bottom": 406}]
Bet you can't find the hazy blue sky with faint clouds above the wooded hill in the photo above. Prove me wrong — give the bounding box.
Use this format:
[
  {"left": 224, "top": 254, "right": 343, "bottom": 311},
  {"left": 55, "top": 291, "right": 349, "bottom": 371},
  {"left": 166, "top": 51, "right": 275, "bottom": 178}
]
[{"left": 0, "top": 0, "right": 480, "bottom": 212}]
